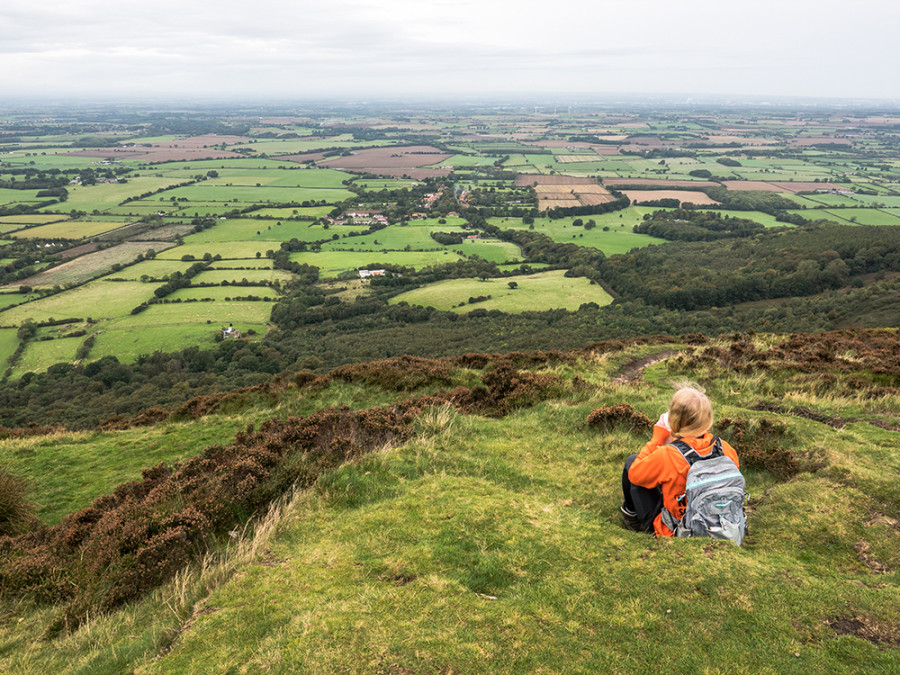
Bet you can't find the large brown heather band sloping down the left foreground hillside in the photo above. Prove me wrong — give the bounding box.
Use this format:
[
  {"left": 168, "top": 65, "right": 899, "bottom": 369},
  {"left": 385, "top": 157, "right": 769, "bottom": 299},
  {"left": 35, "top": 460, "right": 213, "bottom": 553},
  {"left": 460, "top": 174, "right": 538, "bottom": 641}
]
[{"left": 0, "top": 400, "right": 430, "bottom": 633}]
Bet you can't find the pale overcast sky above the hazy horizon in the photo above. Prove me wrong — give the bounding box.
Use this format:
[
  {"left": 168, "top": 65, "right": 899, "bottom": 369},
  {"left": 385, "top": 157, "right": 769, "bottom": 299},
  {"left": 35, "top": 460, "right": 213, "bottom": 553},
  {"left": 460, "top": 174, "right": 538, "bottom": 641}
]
[{"left": 0, "top": 0, "right": 900, "bottom": 101}]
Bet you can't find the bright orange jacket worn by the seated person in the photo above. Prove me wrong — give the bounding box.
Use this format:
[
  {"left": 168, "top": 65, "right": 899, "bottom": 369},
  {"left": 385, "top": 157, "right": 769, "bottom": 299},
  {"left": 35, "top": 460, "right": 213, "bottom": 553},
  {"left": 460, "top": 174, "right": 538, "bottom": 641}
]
[{"left": 628, "top": 427, "right": 740, "bottom": 537}]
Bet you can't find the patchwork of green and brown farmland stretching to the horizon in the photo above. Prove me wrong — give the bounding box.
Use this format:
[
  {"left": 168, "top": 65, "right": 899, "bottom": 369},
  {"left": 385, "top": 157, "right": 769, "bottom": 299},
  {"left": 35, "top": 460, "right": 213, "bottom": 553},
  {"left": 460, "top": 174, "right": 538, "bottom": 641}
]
[{"left": 0, "top": 106, "right": 900, "bottom": 374}]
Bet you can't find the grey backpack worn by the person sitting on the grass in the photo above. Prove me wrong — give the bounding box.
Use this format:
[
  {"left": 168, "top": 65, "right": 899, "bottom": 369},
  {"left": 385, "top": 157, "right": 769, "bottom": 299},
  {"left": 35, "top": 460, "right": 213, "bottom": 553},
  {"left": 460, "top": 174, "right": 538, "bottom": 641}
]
[{"left": 662, "top": 437, "right": 747, "bottom": 546}]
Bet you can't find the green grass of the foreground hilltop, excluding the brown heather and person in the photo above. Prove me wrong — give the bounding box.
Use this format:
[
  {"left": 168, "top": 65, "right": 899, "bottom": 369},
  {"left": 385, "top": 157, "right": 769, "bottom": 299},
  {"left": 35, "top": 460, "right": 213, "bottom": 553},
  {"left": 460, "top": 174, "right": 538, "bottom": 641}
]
[{"left": 0, "top": 345, "right": 900, "bottom": 675}]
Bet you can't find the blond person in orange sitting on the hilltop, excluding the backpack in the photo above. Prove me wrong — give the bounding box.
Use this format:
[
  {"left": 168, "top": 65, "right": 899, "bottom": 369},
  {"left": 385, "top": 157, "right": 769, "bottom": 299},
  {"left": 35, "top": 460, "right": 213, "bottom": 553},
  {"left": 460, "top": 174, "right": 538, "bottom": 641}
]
[{"left": 621, "top": 387, "right": 740, "bottom": 537}]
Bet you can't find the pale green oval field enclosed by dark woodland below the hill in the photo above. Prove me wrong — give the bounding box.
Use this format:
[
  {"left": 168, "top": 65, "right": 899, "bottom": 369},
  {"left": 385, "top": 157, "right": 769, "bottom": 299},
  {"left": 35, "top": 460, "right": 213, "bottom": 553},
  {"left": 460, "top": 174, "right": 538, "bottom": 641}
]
[{"left": 390, "top": 270, "right": 612, "bottom": 313}]
